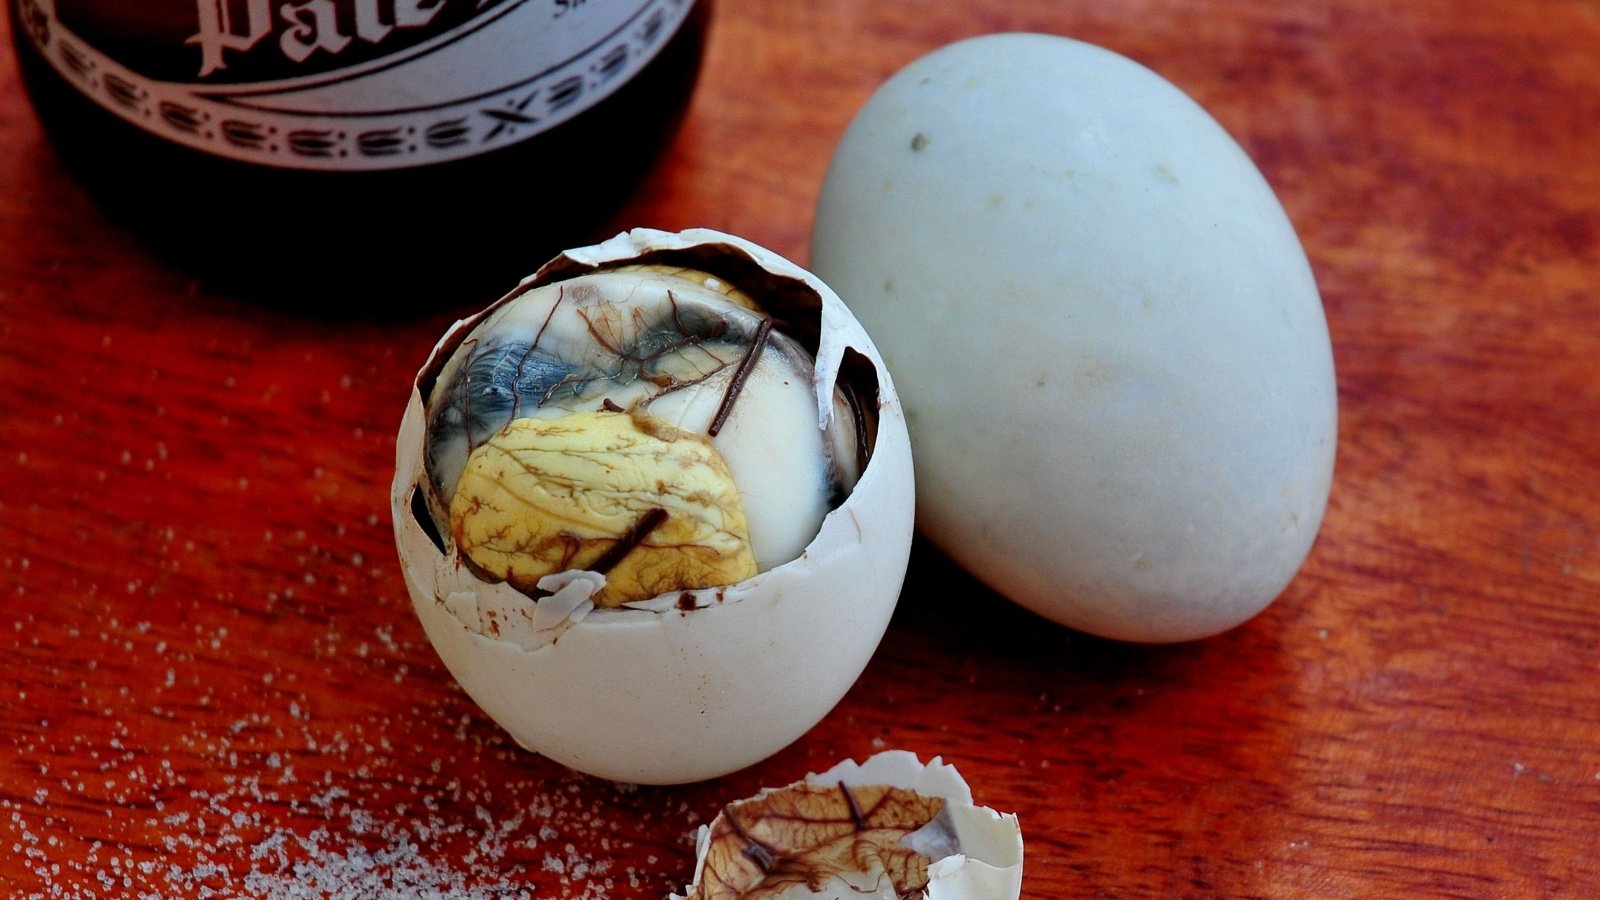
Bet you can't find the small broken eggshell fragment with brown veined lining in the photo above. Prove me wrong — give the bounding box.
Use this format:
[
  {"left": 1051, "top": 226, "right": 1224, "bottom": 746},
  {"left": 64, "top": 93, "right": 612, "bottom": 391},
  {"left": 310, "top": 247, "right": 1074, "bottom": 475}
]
[{"left": 674, "top": 749, "right": 1022, "bottom": 900}]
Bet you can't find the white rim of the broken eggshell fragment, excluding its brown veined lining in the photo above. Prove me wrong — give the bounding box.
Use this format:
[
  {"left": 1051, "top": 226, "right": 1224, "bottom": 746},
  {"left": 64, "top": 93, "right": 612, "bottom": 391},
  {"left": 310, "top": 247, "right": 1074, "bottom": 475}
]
[{"left": 672, "top": 749, "right": 1022, "bottom": 900}]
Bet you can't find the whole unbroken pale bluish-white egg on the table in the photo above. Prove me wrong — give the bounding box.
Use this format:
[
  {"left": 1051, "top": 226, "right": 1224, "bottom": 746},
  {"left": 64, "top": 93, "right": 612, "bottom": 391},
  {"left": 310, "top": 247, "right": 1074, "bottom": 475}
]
[{"left": 813, "top": 34, "right": 1338, "bottom": 641}]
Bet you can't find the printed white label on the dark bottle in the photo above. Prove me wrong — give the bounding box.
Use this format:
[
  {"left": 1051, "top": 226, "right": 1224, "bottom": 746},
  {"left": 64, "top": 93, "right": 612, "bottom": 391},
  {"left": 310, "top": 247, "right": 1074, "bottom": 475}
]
[{"left": 18, "top": 0, "right": 693, "bottom": 170}]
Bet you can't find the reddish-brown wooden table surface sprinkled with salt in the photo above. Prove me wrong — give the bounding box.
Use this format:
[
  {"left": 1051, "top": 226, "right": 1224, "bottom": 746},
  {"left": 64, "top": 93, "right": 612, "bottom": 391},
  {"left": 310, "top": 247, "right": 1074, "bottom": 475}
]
[{"left": 0, "top": 0, "right": 1600, "bottom": 898}]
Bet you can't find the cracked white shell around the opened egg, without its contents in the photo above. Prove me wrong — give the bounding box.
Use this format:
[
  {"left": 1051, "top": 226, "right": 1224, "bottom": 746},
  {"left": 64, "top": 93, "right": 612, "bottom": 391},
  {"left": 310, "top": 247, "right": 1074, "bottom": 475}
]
[{"left": 390, "top": 229, "right": 914, "bottom": 783}]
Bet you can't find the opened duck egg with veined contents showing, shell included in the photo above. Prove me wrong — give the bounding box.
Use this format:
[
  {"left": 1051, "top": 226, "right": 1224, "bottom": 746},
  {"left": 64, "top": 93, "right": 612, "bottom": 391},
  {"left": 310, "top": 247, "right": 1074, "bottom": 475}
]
[{"left": 392, "top": 229, "right": 912, "bottom": 783}]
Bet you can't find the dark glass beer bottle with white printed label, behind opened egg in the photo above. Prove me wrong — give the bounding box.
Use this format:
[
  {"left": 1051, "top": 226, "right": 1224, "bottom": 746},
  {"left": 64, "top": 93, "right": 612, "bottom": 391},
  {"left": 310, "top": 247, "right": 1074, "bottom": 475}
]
[{"left": 8, "top": 0, "right": 710, "bottom": 311}]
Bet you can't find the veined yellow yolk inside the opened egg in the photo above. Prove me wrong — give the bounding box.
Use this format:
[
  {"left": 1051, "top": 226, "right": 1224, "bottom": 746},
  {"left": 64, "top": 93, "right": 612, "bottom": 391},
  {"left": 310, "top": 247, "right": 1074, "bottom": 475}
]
[{"left": 450, "top": 410, "right": 757, "bottom": 607}]
